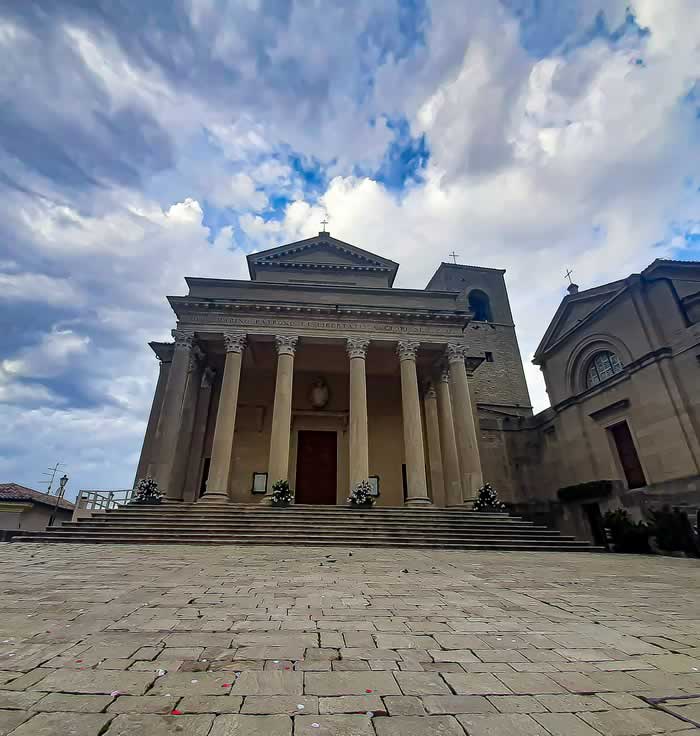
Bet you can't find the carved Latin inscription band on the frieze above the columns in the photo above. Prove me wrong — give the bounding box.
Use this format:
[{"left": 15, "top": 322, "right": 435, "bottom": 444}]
[{"left": 182, "top": 312, "right": 462, "bottom": 336}]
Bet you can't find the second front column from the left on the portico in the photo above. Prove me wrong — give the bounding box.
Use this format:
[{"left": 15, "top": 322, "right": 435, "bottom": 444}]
[{"left": 204, "top": 332, "right": 246, "bottom": 499}]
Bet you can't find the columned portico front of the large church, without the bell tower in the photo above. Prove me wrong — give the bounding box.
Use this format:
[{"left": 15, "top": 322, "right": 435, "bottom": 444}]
[{"left": 139, "top": 233, "right": 481, "bottom": 506}]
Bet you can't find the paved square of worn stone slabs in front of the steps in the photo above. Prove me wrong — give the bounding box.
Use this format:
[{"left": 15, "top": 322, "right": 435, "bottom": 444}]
[{"left": 0, "top": 544, "right": 700, "bottom": 736}]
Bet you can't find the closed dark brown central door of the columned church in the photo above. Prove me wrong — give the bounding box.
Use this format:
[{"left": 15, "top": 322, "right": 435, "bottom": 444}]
[{"left": 295, "top": 432, "right": 338, "bottom": 506}]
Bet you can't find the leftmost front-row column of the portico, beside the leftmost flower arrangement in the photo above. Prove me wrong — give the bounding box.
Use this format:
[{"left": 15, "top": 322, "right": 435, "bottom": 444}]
[{"left": 149, "top": 330, "right": 194, "bottom": 495}]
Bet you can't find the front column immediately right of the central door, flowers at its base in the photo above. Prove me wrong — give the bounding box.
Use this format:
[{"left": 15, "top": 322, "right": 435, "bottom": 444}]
[{"left": 346, "top": 337, "right": 369, "bottom": 491}]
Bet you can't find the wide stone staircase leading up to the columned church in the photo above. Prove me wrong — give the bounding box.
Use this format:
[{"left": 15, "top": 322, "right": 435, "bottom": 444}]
[{"left": 13, "top": 503, "right": 602, "bottom": 552}]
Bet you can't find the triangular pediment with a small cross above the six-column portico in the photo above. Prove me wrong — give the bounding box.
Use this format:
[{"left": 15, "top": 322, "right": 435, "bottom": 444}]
[{"left": 248, "top": 233, "right": 398, "bottom": 285}]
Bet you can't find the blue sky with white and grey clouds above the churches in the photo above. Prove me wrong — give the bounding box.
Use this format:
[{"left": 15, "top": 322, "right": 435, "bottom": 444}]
[{"left": 0, "top": 0, "right": 700, "bottom": 500}]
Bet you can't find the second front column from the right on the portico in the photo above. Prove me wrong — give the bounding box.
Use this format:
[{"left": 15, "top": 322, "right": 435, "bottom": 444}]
[{"left": 396, "top": 341, "right": 430, "bottom": 506}]
